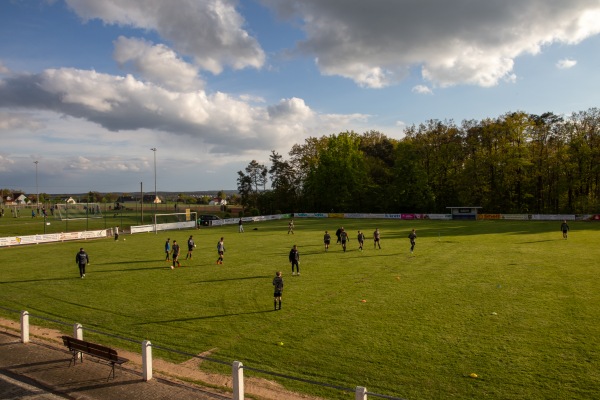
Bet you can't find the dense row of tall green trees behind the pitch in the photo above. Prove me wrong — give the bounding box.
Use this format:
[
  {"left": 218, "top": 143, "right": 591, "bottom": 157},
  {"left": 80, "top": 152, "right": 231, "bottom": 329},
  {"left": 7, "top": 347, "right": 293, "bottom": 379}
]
[{"left": 237, "top": 108, "right": 600, "bottom": 214}]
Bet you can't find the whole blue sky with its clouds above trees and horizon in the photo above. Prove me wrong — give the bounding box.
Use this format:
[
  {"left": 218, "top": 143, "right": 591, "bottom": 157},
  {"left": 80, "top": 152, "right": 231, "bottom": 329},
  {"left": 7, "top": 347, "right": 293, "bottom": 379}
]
[{"left": 0, "top": 0, "right": 600, "bottom": 194}]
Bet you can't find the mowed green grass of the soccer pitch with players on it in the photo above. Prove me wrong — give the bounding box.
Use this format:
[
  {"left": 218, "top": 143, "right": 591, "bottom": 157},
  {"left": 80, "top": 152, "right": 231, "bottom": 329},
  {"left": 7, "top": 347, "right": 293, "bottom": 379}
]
[{"left": 0, "top": 219, "right": 600, "bottom": 400}]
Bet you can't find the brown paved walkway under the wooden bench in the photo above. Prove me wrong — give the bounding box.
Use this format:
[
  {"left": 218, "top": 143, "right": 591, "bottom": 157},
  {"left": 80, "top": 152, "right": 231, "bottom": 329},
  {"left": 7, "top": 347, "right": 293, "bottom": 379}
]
[{"left": 0, "top": 332, "right": 232, "bottom": 400}]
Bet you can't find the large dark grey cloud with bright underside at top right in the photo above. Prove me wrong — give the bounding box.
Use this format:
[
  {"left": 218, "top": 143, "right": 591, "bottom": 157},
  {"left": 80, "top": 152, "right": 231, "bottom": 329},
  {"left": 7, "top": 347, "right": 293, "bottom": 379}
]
[{"left": 262, "top": 0, "right": 600, "bottom": 88}]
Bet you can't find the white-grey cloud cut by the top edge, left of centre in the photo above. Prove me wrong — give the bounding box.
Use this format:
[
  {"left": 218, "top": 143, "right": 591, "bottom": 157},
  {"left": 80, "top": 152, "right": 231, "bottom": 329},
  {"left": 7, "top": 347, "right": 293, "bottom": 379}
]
[{"left": 66, "top": 0, "right": 265, "bottom": 74}]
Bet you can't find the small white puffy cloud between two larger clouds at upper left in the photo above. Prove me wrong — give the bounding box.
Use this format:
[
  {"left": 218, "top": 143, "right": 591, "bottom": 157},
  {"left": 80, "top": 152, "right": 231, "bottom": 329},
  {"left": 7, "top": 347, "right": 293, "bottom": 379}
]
[{"left": 114, "top": 36, "right": 204, "bottom": 91}]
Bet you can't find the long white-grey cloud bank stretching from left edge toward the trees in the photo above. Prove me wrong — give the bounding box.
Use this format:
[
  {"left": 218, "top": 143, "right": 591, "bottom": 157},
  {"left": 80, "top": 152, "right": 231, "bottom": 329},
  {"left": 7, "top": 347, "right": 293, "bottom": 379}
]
[{"left": 0, "top": 68, "right": 366, "bottom": 157}]
